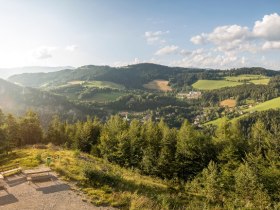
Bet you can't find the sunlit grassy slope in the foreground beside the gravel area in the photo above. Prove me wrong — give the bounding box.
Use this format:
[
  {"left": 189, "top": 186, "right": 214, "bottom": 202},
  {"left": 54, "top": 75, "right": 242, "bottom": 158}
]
[{"left": 0, "top": 148, "right": 192, "bottom": 210}]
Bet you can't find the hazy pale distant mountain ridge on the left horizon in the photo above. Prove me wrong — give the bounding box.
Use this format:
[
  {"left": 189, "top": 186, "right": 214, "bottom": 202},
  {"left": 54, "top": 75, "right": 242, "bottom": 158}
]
[{"left": 0, "top": 66, "right": 74, "bottom": 79}]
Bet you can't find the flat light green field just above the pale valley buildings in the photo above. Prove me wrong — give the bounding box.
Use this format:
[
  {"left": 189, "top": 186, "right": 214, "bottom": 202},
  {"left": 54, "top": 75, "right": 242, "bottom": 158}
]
[{"left": 192, "top": 80, "right": 242, "bottom": 90}]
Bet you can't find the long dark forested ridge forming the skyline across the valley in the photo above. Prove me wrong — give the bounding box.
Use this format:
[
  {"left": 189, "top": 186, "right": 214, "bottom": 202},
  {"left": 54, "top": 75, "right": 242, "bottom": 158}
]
[{"left": 9, "top": 63, "right": 280, "bottom": 89}]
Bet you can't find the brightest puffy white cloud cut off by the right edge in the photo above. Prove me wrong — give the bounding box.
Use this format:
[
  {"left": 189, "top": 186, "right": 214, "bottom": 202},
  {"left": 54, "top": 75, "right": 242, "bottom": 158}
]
[{"left": 253, "top": 13, "right": 280, "bottom": 41}]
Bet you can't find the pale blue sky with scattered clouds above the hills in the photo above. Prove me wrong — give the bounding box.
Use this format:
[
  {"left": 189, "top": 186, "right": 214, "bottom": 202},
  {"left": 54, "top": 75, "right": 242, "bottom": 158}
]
[{"left": 0, "top": 0, "right": 280, "bottom": 70}]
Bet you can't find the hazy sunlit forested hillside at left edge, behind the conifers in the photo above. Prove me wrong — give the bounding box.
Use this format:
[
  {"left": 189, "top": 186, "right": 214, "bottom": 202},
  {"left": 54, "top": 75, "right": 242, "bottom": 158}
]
[{"left": 0, "top": 79, "right": 85, "bottom": 123}]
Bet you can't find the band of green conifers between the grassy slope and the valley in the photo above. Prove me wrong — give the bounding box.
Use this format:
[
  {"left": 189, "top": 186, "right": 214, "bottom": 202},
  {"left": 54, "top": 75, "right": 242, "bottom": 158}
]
[{"left": 0, "top": 110, "right": 280, "bottom": 209}]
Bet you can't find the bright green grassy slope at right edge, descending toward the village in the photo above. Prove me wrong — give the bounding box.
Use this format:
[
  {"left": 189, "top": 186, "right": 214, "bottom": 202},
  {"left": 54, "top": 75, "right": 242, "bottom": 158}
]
[{"left": 205, "top": 97, "right": 280, "bottom": 125}]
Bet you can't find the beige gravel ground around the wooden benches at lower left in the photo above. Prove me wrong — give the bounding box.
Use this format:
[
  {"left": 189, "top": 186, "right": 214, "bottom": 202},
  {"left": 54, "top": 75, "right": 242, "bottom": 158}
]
[{"left": 0, "top": 175, "right": 111, "bottom": 210}]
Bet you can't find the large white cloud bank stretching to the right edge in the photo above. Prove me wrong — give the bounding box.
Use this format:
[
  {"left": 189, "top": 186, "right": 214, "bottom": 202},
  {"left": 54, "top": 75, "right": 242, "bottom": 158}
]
[{"left": 190, "top": 13, "right": 280, "bottom": 53}]
